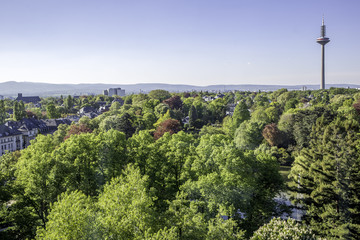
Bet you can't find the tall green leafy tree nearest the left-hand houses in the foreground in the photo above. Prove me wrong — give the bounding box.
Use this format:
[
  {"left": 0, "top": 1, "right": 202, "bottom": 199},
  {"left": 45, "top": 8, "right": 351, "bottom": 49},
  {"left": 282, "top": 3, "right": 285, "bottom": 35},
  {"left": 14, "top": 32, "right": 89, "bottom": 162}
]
[{"left": 14, "top": 135, "right": 58, "bottom": 228}]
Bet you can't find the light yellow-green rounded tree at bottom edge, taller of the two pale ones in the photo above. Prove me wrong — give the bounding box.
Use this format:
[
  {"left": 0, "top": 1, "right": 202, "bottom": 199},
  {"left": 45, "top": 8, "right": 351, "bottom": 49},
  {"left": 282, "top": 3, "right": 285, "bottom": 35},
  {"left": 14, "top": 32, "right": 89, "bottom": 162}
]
[{"left": 98, "top": 166, "right": 157, "bottom": 239}]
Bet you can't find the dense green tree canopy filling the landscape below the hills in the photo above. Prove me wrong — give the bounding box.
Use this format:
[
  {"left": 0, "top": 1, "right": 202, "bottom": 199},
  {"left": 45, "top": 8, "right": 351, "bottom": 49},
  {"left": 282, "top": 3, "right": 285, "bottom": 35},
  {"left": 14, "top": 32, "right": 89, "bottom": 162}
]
[{"left": 0, "top": 88, "right": 360, "bottom": 240}]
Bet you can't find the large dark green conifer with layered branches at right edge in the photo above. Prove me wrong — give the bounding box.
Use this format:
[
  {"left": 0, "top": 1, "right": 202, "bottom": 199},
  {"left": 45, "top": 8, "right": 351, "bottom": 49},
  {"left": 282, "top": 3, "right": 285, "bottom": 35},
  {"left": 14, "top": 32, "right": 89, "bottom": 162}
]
[{"left": 290, "top": 117, "right": 360, "bottom": 239}]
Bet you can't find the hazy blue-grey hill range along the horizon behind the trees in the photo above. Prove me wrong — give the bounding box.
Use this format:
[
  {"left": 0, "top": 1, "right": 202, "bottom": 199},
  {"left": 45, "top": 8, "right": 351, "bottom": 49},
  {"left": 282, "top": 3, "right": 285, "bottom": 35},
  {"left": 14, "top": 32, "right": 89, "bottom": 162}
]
[{"left": 0, "top": 81, "right": 360, "bottom": 97}]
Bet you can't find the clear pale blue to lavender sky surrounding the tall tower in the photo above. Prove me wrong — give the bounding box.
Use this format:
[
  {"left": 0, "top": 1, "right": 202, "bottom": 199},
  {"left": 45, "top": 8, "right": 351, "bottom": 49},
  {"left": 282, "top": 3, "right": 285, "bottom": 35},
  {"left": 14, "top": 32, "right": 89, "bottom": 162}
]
[{"left": 0, "top": 0, "right": 360, "bottom": 86}]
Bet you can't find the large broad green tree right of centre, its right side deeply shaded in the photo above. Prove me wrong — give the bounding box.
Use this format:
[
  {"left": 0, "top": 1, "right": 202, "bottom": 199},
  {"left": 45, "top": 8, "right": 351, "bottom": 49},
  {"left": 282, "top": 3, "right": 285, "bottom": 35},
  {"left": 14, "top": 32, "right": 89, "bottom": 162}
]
[{"left": 186, "top": 135, "right": 282, "bottom": 233}]
